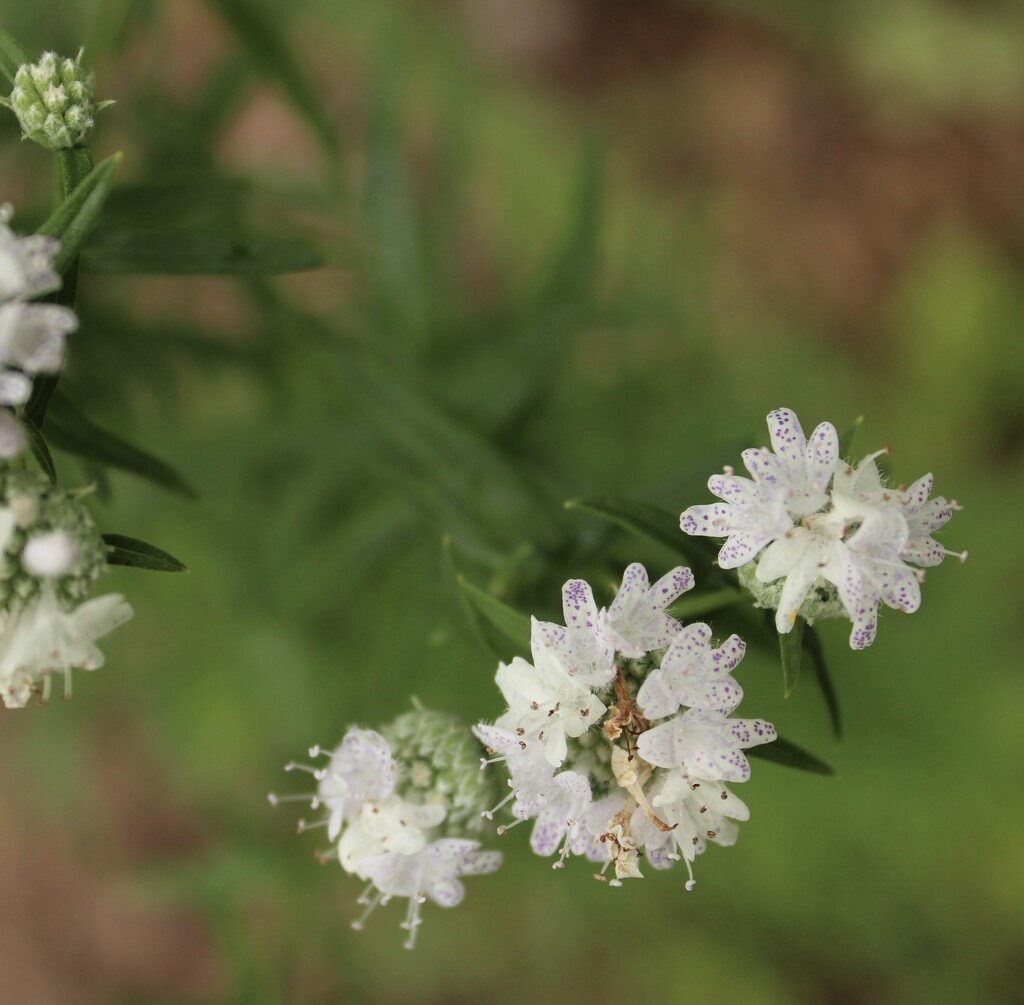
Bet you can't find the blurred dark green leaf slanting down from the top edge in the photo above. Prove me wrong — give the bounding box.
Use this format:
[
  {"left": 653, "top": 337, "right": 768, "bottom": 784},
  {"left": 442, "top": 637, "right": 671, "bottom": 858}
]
[{"left": 204, "top": 0, "right": 339, "bottom": 158}]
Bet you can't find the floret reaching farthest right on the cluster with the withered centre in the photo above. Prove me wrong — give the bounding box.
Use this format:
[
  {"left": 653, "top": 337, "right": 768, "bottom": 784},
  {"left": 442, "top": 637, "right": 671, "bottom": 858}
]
[{"left": 637, "top": 708, "right": 775, "bottom": 782}]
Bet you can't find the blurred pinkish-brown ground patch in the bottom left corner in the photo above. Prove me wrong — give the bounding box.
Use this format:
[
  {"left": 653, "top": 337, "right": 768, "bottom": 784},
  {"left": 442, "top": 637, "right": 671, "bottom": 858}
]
[{"left": 0, "top": 709, "right": 225, "bottom": 1005}]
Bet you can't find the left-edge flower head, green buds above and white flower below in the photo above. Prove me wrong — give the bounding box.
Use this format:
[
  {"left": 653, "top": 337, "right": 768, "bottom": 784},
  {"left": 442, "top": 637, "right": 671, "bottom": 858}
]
[{"left": 0, "top": 471, "right": 132, "bottom": 708}]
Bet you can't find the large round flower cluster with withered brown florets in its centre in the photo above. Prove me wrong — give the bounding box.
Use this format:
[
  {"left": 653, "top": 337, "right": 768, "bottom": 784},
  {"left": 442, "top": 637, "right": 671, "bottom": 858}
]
[{"left": 474, "top": 564, "right": 775, "bottom": 889}]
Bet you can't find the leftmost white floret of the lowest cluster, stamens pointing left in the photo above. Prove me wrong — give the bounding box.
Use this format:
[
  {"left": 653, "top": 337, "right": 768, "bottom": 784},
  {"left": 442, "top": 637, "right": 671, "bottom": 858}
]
[{"left": 310, "top": 728, "right": 397, "bottom": 841}]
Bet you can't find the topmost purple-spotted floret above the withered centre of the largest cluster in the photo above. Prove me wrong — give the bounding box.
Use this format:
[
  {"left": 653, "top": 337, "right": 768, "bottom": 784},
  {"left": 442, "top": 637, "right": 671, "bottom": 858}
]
[{"left": 599, "top": 562, "right": 693, "bottom": 660}]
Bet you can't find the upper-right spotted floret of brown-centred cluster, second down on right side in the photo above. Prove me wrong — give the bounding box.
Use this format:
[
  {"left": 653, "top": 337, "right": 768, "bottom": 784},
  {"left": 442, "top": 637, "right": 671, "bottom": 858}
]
[{"left": 637, "top": 622, "right": 746, "bottom": 719}]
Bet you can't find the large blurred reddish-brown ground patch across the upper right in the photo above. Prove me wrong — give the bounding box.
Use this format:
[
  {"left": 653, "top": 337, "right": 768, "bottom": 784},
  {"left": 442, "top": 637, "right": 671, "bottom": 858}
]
[{"left": 458, "top": 0, "right": 1024, "bottom": 341}]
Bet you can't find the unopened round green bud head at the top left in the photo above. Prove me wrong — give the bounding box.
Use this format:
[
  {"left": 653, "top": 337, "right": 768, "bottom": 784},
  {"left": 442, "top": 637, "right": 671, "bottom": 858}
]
[{"left": 3, "top": 50, "right": 114, "bottom": 150}]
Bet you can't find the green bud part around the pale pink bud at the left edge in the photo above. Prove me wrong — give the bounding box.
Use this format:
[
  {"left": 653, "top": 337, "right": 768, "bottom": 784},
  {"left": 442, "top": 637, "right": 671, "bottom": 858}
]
[{"left": 0, "top": 471, "right": 106, "bottom": 612}]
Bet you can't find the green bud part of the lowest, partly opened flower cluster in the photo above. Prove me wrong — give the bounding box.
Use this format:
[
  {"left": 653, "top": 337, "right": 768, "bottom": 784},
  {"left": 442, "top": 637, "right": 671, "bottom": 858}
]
[{"left": 382, "top": 708, "right": 496, "bottom": 837}]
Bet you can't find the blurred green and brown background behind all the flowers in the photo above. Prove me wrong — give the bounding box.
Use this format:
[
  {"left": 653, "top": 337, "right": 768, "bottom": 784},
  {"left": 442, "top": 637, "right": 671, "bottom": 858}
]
[{"left": 0, "top": 0, "right": 1024, "bottom": 1005}]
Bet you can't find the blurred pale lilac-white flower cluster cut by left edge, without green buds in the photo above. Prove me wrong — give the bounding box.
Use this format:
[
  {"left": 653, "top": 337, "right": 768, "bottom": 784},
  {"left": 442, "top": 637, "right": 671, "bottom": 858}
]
[{"left": 0, "top": 204, "right": 78, "bottom": 459}]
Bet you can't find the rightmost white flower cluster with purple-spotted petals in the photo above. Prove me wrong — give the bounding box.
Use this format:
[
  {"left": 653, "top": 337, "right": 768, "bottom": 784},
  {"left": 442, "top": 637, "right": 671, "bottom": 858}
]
[{"left": 680, "top": 409, "right": 967, "bottom": 650}]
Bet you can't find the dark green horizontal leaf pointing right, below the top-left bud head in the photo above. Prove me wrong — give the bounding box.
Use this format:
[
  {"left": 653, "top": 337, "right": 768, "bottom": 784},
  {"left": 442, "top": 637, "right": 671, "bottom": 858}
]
[{"left": 82, "top": 228, "right": 327, "bottom": 276}]
